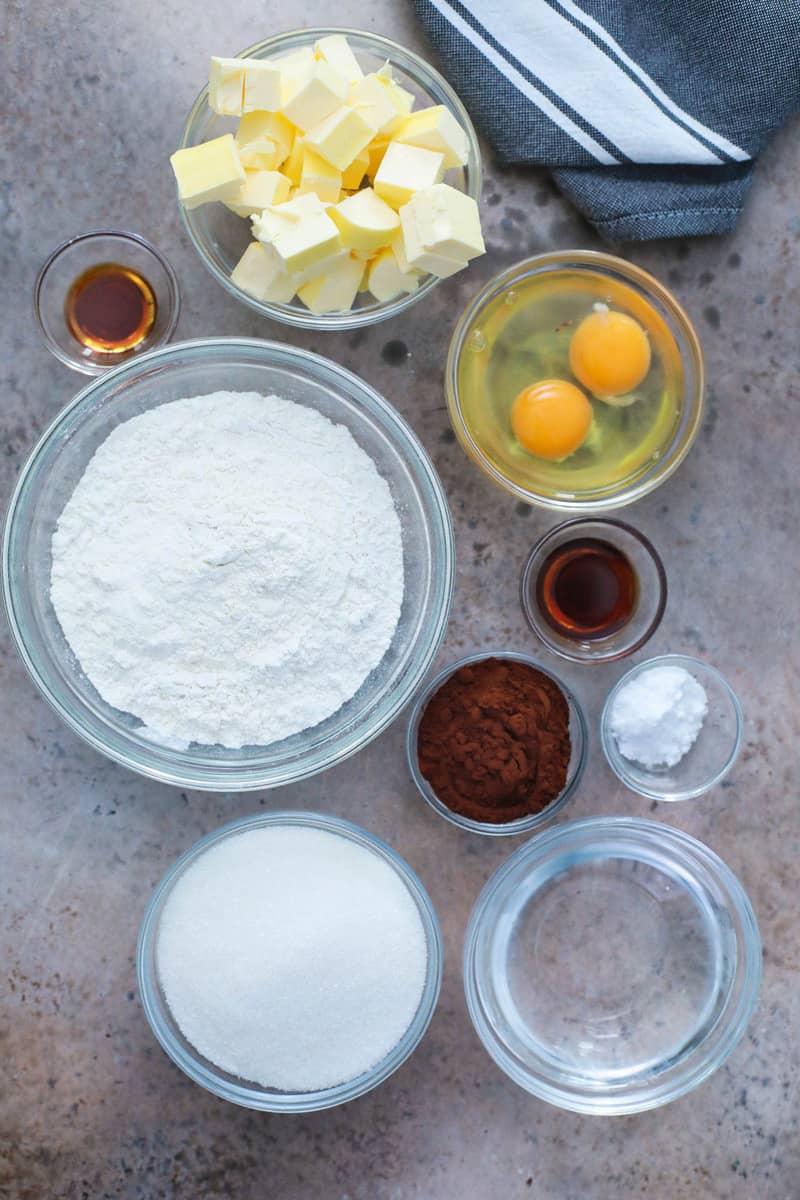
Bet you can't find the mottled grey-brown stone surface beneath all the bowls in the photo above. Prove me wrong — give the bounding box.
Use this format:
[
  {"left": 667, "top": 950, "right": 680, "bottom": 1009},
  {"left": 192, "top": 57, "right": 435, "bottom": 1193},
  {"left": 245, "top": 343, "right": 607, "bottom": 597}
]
[{"left": 0, "top": 0, "right": 800, "bottom": 1200}]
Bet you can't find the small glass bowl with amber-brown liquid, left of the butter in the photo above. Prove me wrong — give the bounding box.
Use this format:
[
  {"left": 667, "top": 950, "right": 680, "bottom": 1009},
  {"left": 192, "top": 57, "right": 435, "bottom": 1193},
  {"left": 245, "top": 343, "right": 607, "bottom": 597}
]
[{"left": 34, "top": 229, "right": 180, "bottom": 376}]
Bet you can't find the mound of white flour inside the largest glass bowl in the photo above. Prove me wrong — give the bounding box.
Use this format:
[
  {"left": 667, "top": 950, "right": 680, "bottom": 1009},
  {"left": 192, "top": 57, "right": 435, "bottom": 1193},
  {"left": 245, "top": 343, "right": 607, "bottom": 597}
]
[{"left": 50, "top": 392, "right": 403, "bottom": 748}]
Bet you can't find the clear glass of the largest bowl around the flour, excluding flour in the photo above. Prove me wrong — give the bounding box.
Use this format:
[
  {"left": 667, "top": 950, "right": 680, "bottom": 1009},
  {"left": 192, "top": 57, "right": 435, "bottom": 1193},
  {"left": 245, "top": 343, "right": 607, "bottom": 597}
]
[{"left": 2, "top": 337, "right": 455, "bottom": 791}]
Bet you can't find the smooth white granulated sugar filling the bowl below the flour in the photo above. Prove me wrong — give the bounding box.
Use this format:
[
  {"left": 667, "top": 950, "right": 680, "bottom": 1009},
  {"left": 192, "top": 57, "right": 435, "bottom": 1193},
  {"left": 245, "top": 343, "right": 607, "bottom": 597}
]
[{"left": 156, "top": 827, "right": 427, "bottom": 1092}]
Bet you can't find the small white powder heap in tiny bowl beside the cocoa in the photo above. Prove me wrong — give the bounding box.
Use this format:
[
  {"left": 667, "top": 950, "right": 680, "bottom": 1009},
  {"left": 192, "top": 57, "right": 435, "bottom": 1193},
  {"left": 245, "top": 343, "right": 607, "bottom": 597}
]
[{"left": 610, "top": 666, "right": 709, "bottom": 767}]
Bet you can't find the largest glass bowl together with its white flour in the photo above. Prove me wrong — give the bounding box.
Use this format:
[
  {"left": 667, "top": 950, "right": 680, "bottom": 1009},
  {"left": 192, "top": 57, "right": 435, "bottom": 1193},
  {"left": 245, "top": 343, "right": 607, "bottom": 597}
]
[{"left": 2, "top": 338, "right": 453, "bottom": 791}]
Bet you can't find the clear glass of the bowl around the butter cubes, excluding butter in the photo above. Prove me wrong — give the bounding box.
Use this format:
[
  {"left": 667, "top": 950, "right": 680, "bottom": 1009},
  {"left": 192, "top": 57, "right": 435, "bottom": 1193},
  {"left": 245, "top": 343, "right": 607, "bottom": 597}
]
[{"left": 178, "top": 28, "right": 481, "bottom": 329}]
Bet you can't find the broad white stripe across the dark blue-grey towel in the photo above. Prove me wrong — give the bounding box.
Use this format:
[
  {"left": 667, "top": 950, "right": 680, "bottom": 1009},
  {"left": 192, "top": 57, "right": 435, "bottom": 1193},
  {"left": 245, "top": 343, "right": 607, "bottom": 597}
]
[{"left": 450, "top": 0, "right": 734, "bottom": 164}]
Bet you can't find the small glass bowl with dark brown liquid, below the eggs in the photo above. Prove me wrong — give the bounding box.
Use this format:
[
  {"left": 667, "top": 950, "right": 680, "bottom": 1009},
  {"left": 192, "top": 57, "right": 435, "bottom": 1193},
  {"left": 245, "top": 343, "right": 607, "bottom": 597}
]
[{"left": 519, "top": 518, "right": 667, "bottom": 662}]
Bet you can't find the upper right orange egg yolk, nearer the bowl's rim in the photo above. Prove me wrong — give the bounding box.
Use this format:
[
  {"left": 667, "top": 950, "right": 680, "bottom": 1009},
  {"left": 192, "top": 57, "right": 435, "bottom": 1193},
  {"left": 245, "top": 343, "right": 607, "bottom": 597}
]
[{"left": 570, "top": 308, "right": 650, "bottom": 400}]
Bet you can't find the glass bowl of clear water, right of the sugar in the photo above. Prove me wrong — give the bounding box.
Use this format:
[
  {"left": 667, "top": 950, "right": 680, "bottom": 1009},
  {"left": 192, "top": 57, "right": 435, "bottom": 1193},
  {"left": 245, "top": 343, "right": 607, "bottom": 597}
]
[{"left": 464, "top": 817, "right": 762, "bottom": 1116}]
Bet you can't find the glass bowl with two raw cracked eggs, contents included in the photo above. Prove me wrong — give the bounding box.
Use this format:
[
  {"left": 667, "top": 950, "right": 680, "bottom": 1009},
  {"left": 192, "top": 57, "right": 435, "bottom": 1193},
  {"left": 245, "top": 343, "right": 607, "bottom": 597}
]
[{"left": 445, "top": 250, "right": 703, "bottom": 512}]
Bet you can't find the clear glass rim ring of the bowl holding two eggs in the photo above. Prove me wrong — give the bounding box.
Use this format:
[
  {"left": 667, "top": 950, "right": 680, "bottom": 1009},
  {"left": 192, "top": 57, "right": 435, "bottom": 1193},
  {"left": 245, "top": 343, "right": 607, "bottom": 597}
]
[{"left": 445, "top": 250, "right": 704, "bottom": 512}]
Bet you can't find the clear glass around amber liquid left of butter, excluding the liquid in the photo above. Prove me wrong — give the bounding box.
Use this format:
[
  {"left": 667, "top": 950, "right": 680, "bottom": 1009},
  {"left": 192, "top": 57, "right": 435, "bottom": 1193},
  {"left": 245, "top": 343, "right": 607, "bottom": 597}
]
[{"left": 34, "top": 229, "right": 180, "bottom": 376}]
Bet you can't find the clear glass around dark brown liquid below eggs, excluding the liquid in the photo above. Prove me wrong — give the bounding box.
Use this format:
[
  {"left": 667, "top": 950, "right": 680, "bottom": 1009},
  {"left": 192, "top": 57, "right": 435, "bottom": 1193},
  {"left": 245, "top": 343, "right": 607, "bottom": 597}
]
[{"left": 519, "top": 517, "right": 667, "bottom": 662}]
